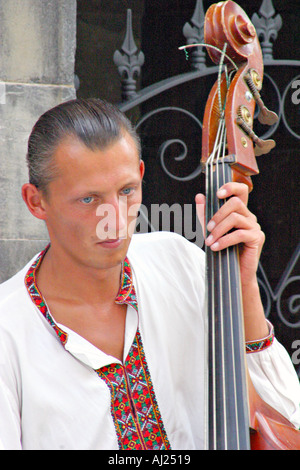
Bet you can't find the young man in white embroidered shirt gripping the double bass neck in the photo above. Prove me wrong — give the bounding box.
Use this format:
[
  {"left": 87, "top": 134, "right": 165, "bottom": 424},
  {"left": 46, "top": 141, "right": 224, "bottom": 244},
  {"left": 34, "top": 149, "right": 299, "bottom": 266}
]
[{"left": 0, "top": 100, "right": 300, "bottom": 450}]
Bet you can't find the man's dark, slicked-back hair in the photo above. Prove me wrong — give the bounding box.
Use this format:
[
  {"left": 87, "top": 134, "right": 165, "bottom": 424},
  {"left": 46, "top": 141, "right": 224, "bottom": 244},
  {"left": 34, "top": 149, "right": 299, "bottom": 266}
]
[{"left": 26, "top": 98, "right": 141, "bottom": 193}]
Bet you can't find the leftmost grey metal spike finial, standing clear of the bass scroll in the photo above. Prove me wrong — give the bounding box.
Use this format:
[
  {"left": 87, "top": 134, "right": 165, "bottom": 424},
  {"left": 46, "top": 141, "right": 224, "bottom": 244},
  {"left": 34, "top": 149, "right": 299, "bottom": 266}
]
[{"left": 113, "top": 9, "right": 145, "bottom": 101}]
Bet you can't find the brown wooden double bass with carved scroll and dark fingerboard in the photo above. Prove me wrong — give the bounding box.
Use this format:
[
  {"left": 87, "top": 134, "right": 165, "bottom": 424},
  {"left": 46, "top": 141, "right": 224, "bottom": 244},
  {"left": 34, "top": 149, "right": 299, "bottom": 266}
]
[{"left": 192, "top": 0, "right": 300, "bottom": 450}]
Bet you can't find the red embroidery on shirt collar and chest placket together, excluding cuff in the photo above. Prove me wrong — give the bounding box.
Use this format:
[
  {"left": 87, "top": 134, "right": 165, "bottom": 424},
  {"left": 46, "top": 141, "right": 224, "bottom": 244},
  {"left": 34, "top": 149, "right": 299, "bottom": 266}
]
[{"left": 25, "top": 246, "right": 170, "bottom": 450}]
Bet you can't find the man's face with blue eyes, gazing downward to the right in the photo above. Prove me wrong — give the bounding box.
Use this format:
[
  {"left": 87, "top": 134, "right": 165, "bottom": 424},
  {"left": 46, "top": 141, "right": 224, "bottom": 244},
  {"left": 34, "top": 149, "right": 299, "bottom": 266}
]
[{"left": 42, "top": 133, "right": 144, "bottom": 269}]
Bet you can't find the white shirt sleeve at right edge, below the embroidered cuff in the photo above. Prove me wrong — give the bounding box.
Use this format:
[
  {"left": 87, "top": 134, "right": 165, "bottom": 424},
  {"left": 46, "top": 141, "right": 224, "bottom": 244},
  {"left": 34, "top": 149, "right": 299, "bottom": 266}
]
[{"left": 247, "top": 338, "right": 300, "bottom": 429}]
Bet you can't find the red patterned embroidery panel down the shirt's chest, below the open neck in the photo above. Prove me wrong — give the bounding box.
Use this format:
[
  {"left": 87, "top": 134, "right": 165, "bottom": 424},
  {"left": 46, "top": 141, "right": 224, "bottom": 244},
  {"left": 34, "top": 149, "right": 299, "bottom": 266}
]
[{"left": 97, "top": 332, "right": 170, "bottom": 450}]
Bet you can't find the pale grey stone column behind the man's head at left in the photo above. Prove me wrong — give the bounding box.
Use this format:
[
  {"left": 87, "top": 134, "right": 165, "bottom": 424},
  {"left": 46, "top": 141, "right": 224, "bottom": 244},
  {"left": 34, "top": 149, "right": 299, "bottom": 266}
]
[{"left": 0, "top": 0, "right": 76, "bottom": 282}]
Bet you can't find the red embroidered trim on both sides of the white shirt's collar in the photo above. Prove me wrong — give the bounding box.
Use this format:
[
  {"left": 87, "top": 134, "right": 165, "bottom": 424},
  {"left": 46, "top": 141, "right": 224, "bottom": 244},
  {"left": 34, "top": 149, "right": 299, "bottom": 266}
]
[{"left": 25, "top": 245, "right": 138, "bottom": 345}]
